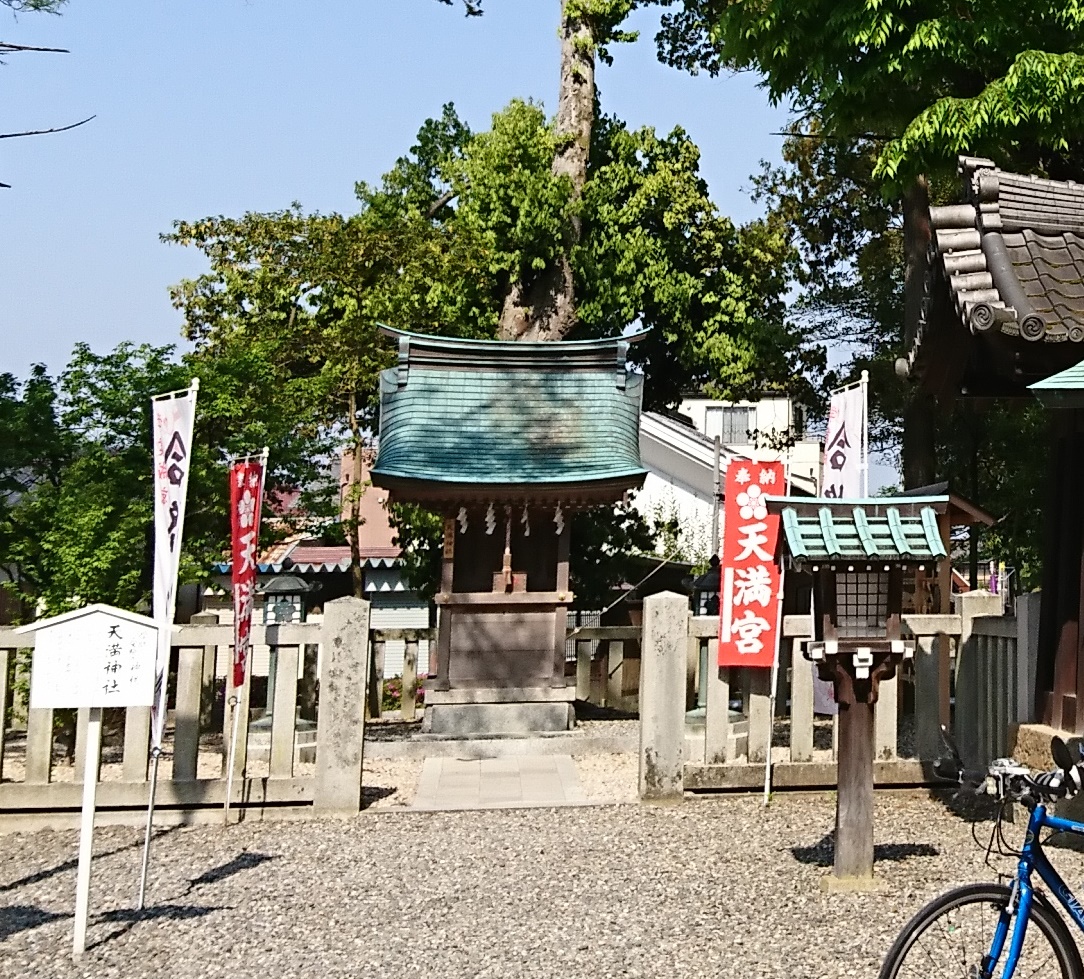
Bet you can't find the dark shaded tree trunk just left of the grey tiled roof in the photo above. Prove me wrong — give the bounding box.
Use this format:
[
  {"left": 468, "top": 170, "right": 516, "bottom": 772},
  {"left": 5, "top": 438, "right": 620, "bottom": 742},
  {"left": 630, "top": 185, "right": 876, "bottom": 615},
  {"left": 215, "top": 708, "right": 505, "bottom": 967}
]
[{"left": 902, "top": 177, "right": 937, "bottom": 489}]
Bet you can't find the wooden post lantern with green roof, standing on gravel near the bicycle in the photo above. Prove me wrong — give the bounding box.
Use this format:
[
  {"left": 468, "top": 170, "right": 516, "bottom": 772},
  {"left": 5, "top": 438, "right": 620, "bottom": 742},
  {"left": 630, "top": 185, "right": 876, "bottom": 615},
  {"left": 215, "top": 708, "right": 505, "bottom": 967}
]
[{"left": 770, "top": 497, "right": 949, "bottom": 890}]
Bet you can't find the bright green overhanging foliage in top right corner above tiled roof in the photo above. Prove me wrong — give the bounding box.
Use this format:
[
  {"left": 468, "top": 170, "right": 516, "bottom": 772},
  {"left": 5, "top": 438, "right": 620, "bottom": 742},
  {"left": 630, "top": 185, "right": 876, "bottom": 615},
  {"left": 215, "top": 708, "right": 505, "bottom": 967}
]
[{"left": 658, "top": 0, "right": 1084, "bottom": 186}]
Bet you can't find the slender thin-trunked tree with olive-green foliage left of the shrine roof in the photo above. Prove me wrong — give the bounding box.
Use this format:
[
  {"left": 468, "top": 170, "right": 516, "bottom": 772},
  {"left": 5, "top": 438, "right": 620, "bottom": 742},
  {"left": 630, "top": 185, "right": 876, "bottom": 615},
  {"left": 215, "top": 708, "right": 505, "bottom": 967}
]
[{"left": 164, "top": 205, "right": 492, "bottom": 595}]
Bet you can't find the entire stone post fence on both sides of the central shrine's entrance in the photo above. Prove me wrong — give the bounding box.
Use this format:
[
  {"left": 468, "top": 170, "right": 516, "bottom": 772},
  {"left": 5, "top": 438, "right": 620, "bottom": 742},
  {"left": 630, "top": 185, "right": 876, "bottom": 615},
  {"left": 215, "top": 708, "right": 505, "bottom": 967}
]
[{"left": 0, "top": 593, "right": 1038, "bottom": 829}]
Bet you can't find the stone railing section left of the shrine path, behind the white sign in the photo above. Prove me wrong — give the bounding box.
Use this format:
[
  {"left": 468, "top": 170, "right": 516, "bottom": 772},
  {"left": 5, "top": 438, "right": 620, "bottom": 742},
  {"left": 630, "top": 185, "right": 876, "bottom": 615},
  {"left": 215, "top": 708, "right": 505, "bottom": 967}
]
[{"left": 0, "top": 598, "right": 370, "bottom": 828}]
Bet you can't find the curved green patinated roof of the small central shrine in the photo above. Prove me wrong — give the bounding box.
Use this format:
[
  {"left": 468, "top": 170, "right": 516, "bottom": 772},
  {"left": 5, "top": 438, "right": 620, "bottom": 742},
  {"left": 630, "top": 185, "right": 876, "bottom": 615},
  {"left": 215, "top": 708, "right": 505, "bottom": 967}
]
[{"left": 372, "top": 329, "right": 646, "bottom": 486}]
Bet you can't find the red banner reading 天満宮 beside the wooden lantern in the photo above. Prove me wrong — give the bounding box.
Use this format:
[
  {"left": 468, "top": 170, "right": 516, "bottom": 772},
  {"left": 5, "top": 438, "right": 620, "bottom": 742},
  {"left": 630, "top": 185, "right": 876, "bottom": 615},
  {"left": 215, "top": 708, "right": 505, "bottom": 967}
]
[{"left": 719, "top": 460, "right": 786, "bottom": 667}]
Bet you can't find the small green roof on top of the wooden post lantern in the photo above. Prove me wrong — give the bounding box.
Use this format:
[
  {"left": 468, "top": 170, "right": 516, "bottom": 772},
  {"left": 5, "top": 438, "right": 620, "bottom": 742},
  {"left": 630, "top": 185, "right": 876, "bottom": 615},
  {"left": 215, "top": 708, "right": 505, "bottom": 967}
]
[{"left": 770, "top": 497, "right": 949, "bottom": 564}]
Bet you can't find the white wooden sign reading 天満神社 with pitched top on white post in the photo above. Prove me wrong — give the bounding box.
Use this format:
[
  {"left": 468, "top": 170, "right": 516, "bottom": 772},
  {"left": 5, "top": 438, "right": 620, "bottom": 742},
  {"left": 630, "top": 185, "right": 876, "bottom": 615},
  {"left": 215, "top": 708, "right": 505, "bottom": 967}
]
[{"left": 16, "top": 605, "right": 158, "bottom": 957}]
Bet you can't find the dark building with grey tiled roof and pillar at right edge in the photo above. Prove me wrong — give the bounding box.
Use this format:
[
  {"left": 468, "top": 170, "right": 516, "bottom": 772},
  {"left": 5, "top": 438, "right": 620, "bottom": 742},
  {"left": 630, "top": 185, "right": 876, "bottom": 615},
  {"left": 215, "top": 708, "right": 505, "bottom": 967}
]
[{"left": 896, "top": 157, "right": 1084, "bottom": 733}]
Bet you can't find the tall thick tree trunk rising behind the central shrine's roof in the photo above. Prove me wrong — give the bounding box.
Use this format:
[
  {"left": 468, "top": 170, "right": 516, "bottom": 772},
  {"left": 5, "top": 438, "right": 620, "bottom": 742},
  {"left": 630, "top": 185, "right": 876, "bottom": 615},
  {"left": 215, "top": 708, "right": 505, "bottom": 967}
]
[{"left": 496, "top": 0, "right": 595, "bottom": 340}]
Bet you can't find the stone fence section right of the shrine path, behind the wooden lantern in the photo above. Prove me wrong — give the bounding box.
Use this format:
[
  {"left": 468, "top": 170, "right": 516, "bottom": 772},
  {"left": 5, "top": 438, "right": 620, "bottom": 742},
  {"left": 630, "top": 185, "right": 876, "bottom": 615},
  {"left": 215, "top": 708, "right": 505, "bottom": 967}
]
[{"left": 633, "top": 592, "right": 1038, "bottom": 799}]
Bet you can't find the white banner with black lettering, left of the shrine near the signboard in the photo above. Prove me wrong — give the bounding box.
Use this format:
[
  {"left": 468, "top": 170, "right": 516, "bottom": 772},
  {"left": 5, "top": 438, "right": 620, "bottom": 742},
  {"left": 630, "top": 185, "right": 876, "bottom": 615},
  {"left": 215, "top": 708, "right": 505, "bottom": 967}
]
[{"left": 151, "top": 378, "right": 199, "bottom": 750}]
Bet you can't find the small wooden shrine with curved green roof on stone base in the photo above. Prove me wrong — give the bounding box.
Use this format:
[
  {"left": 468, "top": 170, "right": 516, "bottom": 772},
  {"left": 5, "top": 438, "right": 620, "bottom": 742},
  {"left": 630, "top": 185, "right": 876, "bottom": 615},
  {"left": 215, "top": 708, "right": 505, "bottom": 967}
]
[{"left": 372, "top": 327, "right": 646, "bottom": 734}]
